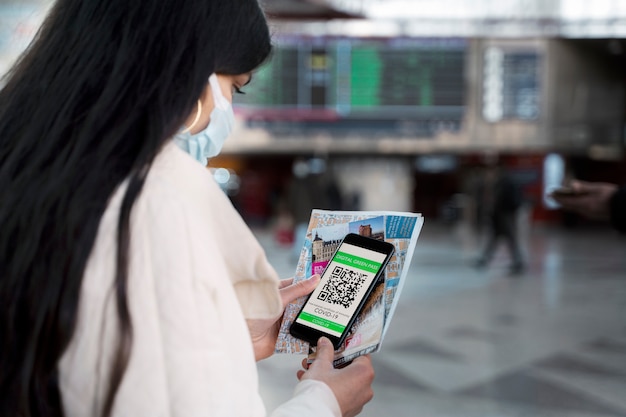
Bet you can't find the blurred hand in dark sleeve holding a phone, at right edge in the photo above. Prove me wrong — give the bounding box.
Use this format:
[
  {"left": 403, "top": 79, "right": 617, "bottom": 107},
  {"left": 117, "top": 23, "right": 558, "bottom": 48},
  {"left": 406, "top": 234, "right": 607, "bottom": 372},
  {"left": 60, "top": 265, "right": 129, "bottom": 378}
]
[{"left": 550, "top": 180, "right": 626, "bottom": 233}]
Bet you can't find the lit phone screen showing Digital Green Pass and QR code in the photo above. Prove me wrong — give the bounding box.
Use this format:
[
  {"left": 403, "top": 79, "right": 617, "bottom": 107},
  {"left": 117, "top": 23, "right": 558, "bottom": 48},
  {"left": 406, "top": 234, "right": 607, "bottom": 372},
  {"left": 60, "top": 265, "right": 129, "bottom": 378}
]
[{"left": 295, "top": 242, "right": 387, "bottom": 338}]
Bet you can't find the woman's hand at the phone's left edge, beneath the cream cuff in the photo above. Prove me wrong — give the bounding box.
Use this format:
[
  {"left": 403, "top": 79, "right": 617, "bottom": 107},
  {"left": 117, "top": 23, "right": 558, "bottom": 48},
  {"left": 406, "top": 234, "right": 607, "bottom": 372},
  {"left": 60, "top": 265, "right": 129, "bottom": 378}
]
[{"left": 246, "top": 275, "right": 320, "bottom": 361}]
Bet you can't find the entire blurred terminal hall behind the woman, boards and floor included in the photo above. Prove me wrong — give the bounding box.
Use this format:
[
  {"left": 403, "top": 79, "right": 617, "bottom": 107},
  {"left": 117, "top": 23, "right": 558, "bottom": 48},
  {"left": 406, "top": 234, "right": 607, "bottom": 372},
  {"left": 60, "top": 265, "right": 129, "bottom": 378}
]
[{"left": 0, "top": 0, "right": 626, "bottom": 417}]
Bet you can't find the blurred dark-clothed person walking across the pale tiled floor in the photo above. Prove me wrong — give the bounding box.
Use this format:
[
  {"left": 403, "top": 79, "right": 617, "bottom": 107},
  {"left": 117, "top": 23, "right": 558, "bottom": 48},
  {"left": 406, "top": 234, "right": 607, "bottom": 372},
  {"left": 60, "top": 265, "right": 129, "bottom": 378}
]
[{"left": 475, "top": 160, "right": 524, "bottom": 275}]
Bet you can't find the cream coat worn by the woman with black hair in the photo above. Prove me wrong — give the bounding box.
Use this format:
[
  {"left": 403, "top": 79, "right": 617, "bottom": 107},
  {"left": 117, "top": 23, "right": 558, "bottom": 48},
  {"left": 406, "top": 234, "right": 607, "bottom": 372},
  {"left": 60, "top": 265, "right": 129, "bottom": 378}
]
[{"left": 60, "top": 143, "right": 340, "bottom": 417}]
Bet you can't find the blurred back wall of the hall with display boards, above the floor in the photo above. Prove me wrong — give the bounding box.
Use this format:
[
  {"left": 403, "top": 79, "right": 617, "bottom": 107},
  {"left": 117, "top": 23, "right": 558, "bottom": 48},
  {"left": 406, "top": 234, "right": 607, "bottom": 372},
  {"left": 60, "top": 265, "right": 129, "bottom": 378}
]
[{"left": 0, "top": 0, "right": 626, "bottom": 228}]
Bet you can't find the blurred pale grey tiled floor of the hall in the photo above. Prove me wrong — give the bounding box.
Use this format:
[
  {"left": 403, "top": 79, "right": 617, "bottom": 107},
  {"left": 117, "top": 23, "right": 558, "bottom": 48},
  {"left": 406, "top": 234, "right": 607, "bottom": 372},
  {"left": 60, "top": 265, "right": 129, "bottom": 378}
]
[{"left": 252, "top": 220, "right": 626, "bottom": 417}]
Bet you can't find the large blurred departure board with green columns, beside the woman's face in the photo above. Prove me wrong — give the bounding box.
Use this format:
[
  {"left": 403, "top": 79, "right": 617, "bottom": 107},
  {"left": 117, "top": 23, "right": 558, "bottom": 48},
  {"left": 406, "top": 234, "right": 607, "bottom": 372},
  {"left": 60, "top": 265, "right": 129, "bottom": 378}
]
[{"left": 235, "top": 37, "right": 467, "bottom": 136}]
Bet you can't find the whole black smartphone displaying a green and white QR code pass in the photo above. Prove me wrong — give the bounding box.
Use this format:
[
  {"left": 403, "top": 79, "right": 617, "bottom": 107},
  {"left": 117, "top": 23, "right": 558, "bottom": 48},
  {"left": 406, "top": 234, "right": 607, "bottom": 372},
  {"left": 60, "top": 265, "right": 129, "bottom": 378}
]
[{"left": 289, "top": 233, "right": 395, "bottom": 349}]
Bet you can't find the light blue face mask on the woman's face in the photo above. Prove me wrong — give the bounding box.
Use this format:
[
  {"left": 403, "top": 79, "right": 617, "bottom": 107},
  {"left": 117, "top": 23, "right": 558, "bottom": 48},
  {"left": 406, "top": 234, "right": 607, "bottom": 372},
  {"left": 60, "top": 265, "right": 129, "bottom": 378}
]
[{"left": 174, "top": 74, "right": 235, "bottom": 165}]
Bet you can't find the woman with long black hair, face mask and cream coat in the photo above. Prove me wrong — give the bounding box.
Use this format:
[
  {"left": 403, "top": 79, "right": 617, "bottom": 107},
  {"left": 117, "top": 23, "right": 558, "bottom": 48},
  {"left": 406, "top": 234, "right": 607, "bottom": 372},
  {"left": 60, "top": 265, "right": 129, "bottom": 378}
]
[{"left": 0, "top": 0, "right": 373, "bottom": 417}]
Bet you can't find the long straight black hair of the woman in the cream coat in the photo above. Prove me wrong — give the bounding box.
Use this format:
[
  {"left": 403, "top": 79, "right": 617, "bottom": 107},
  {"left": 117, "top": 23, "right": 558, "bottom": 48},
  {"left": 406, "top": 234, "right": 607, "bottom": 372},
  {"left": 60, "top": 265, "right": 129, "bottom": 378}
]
[{"left": 0, "top": 0, "right": 271, "bottom": 417}]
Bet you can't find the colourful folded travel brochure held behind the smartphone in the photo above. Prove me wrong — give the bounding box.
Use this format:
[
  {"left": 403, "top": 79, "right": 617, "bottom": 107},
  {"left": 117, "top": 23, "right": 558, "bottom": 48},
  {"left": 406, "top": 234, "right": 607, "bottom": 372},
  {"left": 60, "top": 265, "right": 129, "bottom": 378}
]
[{"left": 275, "top": 209, "right": 424, "bottom": 367}]
